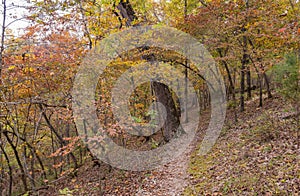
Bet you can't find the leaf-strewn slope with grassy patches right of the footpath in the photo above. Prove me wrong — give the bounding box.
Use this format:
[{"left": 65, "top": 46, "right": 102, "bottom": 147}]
[{"left": 184, "top": 97, "right": 300, "bottom": 195}]
